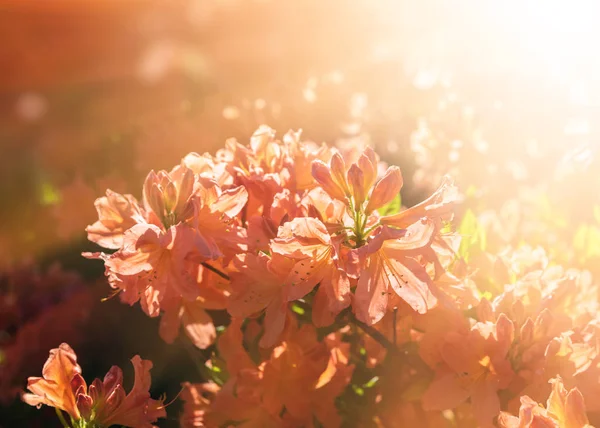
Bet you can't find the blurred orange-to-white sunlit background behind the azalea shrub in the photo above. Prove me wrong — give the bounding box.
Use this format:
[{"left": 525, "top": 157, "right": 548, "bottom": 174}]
[{"left": 0, "top": 0, "right": 600, "bottom": 428}]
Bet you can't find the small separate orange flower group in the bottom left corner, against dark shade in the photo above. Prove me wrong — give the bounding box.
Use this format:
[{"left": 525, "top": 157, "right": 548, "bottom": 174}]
[{"left": 23, "top": 343, "right": 166, "bottom": 428}]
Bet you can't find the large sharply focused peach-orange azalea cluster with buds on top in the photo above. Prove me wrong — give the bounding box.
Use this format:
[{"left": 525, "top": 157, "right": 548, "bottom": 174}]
[{"left": 82, "top": 127, "right": 457, "bottom": 348}]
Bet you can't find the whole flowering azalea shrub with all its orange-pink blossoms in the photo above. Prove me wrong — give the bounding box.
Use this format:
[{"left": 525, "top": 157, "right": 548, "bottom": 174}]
[{"left": 23, "top": 126, "right": 600, "bottom": 428}]
